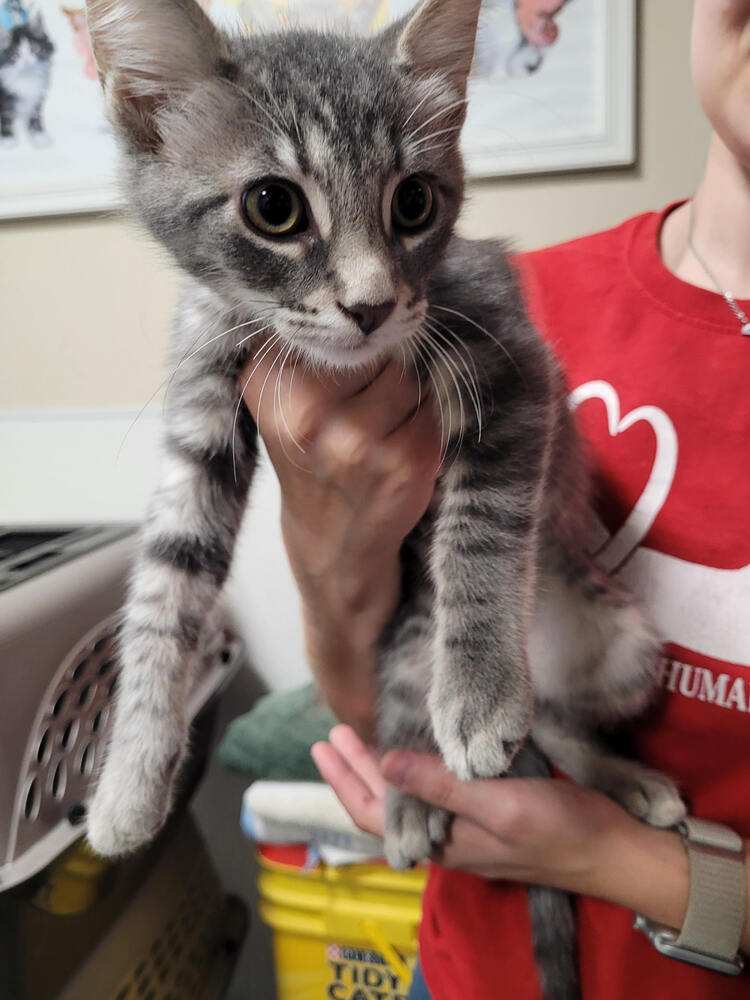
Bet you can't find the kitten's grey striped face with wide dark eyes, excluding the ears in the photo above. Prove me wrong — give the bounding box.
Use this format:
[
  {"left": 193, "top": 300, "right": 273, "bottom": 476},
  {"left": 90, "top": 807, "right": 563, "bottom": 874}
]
[{"left": 86, "top": 0, "right": 478, "bottom": 367}]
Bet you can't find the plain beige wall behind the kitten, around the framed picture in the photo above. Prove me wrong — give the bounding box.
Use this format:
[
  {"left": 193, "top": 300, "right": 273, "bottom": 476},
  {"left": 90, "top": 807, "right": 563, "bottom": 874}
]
[{"left": 0, "top": 0, "right": 708, "bottom": 409}]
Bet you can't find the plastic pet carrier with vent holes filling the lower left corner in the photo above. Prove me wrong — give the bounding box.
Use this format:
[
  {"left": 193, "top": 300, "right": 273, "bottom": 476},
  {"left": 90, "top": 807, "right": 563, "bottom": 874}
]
[{"left": 0, "top": 526, "right": 250, "bottom": 1000}]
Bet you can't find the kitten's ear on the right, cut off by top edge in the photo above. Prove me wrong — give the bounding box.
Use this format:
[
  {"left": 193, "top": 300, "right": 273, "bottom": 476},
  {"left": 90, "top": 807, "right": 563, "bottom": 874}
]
[{"left": 396, "top": 0, "right": 482, "bottom": 97}]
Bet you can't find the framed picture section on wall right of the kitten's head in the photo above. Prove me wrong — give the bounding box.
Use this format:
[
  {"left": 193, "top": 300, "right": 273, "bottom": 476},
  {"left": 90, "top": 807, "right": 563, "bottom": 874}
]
[{"left": 463, "top": 0, "right": 636, "bottom": 177}]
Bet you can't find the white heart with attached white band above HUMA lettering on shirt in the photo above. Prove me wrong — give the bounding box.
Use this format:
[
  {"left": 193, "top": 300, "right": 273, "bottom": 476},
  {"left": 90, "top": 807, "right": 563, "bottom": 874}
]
[{"left": 570, "top": 381, "right": 750, "bottom": 667}]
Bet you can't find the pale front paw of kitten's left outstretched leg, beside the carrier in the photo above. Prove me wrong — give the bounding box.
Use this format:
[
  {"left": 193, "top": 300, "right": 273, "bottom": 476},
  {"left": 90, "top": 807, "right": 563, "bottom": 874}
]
[{"left": 86, "top": 758, "right": 180, "bottom": 857}]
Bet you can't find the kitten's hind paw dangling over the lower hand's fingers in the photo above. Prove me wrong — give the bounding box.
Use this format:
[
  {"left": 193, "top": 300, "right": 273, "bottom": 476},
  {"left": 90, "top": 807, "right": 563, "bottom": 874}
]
[{"left": 385, "top": 787, "right": 451, "bottom": 871}]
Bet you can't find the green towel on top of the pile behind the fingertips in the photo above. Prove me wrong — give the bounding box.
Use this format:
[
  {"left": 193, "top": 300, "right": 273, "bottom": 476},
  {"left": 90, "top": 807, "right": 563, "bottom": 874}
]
[{"left": 219, "top": 684, "right": 336, "bottom": 781}]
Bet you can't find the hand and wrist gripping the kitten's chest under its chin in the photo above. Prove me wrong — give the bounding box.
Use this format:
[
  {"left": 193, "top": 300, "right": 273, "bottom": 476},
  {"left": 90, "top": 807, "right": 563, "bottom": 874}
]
[{"left": 240, "top": 349, "right": 440, "bottom": 734}]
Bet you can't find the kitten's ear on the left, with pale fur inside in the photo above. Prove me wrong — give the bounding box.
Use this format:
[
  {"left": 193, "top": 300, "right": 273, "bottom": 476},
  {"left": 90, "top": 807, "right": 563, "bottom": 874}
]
[{"left": 86, "top": 0, "right": 225, "bottom": 151}]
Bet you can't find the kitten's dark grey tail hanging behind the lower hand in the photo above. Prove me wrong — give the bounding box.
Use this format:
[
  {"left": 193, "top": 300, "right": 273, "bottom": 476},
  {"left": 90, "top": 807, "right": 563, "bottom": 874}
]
[{"left": 510, "top": 739, "right": 581, "bottom": 1000}]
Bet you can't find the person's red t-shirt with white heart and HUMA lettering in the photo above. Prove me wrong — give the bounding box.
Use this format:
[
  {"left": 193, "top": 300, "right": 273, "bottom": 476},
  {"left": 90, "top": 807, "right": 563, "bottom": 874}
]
[{"left": 421, "top": 207, "right": 750, "bottom": 1000}]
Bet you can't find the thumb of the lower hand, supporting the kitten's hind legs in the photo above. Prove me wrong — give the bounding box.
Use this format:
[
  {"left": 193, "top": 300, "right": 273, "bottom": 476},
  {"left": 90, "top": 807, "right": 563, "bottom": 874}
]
[{"left": 380, "top": 750, "right": 506, "bottom": 830}]
